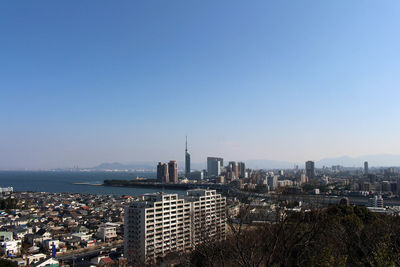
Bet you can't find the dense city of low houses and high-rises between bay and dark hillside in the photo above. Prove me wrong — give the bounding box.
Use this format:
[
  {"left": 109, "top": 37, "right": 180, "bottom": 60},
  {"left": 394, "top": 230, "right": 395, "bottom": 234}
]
[{"left": 0, "top": 140, "right": 400, "bottom": 266}]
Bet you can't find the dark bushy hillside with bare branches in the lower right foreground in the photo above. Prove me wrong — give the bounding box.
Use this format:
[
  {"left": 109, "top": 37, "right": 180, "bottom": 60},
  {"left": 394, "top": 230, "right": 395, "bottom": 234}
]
[{"left": 189, "top": 206, "right": 400, "bottom": 266}]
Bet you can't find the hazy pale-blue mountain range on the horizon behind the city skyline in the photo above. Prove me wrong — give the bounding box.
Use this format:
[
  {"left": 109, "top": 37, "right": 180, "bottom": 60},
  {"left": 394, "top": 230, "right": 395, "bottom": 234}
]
[{"left": 91, "top": 154, "right": 400, "bottom": 171}]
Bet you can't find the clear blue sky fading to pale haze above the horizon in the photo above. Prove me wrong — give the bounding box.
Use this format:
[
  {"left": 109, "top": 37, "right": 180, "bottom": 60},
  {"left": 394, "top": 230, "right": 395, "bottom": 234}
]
[{"left": 0, "top": 0, "right": 400, "bottom": 168}]
